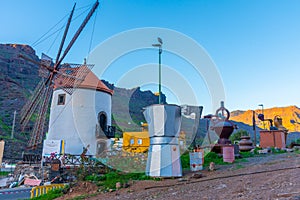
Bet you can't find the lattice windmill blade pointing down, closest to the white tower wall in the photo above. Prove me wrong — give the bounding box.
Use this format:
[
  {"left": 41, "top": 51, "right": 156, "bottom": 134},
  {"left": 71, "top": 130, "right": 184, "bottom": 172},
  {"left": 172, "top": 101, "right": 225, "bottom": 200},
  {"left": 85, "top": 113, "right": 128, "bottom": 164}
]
[{"left": 28, "top": 86, "right": 53, "bottom": 149}]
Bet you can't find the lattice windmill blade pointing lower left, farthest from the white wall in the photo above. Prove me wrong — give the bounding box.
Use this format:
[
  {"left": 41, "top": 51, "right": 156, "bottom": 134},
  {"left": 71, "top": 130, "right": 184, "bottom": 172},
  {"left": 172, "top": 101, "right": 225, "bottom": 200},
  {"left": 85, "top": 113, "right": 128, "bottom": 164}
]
[{"left": 20, "top": 79, "right": 45, "bottom": 130}]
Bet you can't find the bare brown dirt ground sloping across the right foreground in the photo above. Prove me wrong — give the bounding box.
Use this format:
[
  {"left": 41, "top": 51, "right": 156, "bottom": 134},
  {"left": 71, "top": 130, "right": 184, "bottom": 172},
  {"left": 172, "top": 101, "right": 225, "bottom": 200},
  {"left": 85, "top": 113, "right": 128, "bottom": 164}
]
[{"left": 59, "top": 153, "right": 300, "bottom": 200}]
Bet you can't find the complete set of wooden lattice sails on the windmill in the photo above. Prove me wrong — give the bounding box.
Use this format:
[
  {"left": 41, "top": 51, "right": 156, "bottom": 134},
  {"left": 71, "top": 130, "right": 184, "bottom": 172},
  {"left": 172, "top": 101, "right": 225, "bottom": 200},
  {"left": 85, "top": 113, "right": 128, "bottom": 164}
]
[{"left": 19, "top": 1, "right": 99, "bottom": 149}]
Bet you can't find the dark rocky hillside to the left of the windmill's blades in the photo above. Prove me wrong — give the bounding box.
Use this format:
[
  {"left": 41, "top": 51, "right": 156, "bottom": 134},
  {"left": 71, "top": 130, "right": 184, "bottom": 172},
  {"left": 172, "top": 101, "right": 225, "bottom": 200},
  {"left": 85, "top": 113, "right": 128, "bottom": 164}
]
[{"left": 0, "top": 44, "right": 39, "bottom": 157}]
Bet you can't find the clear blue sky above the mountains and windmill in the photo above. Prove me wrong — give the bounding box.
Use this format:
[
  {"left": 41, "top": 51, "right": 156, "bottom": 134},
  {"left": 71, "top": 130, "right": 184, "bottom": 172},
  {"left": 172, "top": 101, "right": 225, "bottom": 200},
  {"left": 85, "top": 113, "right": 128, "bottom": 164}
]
[{"left": 0, "top": 0, "right": 300, "bottom": 113}]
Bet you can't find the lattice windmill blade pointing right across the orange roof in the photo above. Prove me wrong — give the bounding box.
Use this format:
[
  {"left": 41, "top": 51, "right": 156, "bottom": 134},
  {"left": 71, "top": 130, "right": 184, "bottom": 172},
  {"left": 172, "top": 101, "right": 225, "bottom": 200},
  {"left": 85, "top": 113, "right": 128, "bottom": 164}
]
[{"left": 55, "top": 64, "right": 94, "bottom": 95}]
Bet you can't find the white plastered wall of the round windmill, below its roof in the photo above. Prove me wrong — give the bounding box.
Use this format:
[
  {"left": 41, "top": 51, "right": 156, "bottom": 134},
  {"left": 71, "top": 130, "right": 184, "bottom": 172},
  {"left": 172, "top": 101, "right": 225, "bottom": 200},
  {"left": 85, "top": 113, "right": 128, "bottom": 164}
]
[{"left": 47, "top": 88, "right": 111, "bottom": 155}]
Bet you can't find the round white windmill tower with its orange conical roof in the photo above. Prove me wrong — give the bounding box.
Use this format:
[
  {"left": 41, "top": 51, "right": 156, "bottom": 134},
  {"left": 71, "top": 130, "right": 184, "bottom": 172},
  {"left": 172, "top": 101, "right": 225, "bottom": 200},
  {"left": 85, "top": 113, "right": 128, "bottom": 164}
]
[{"left": 43, "top": 65, "right": 114, "bottom": 156}]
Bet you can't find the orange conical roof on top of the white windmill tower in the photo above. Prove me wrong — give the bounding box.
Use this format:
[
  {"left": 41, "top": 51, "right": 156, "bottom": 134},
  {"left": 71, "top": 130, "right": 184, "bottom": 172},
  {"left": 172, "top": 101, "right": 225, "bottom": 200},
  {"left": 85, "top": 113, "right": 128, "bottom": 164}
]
[{"left": 54, "top": 65, "right": 113, "bottom": 95}]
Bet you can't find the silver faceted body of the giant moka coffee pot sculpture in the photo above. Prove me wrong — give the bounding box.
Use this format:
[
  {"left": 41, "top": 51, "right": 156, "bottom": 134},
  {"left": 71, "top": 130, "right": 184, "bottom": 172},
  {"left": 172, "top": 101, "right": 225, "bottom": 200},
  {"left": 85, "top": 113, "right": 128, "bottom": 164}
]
[{"left": 144, "top": 104, "right": 182, "bottom": 177}]
